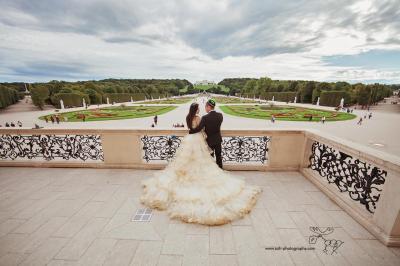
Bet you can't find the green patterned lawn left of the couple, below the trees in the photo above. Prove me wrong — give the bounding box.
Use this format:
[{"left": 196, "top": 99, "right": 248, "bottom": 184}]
[{"left": 39, "top": 106, "right": 176, "bottom": 122}]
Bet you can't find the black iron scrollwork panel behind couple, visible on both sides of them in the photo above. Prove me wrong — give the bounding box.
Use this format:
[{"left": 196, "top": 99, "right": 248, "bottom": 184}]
[{"left": 141, "top": 136, "right": 270, "bottom": 164}]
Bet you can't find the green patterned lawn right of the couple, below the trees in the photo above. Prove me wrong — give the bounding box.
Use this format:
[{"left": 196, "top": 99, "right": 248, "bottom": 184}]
[{"left": 220, "top": 105, "right": 356, "bottom": 122}]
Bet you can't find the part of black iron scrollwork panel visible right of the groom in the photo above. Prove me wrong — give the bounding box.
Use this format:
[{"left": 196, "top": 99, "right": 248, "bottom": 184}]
[{"left": 222, "top": 137, "right": 270, "bottom": 164}]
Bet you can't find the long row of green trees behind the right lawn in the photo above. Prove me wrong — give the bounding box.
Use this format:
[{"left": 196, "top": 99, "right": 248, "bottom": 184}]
[{"left": 218, "top": 77, "right": 400, "bottom": 106}]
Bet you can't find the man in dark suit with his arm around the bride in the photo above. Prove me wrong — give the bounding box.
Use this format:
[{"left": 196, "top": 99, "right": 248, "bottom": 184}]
[{"left": 189, "top": 99, "right": 224, "bottom": 169}]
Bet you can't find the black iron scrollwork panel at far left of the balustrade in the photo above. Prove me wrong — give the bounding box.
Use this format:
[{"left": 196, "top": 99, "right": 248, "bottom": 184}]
[{"left": 0, "top": 135, "right": 104, "bottom": 161}]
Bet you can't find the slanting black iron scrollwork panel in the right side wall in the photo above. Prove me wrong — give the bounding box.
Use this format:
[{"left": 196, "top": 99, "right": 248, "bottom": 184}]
[{"left": 309, "top": 141, "right": 387, "bottom": 213}]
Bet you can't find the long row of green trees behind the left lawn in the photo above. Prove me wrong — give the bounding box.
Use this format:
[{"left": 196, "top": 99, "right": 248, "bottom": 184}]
[{"left": 25, "top": 79, "right": 193, "bottom": 108}]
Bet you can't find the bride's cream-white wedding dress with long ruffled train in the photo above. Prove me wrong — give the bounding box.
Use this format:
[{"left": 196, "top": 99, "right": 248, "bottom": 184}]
[{"left": 140, "top": 116, "right": 261, "bottom": 225}]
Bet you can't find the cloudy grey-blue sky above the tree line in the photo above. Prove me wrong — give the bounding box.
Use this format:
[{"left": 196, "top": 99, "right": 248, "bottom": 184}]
[{"left": 0, "top": 0, "right": 400, "bottom": 84}]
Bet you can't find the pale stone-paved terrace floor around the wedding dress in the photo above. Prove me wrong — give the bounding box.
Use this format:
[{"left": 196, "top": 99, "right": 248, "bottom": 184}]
[{"left": 0, "top": 168, "right": 400, "bottom": 266}]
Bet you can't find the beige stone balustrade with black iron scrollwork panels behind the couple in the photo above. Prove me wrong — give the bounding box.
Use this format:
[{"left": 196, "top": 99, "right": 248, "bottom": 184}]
[{"left": 0, "top": 129, "right": 400, "bottom": 246}]
